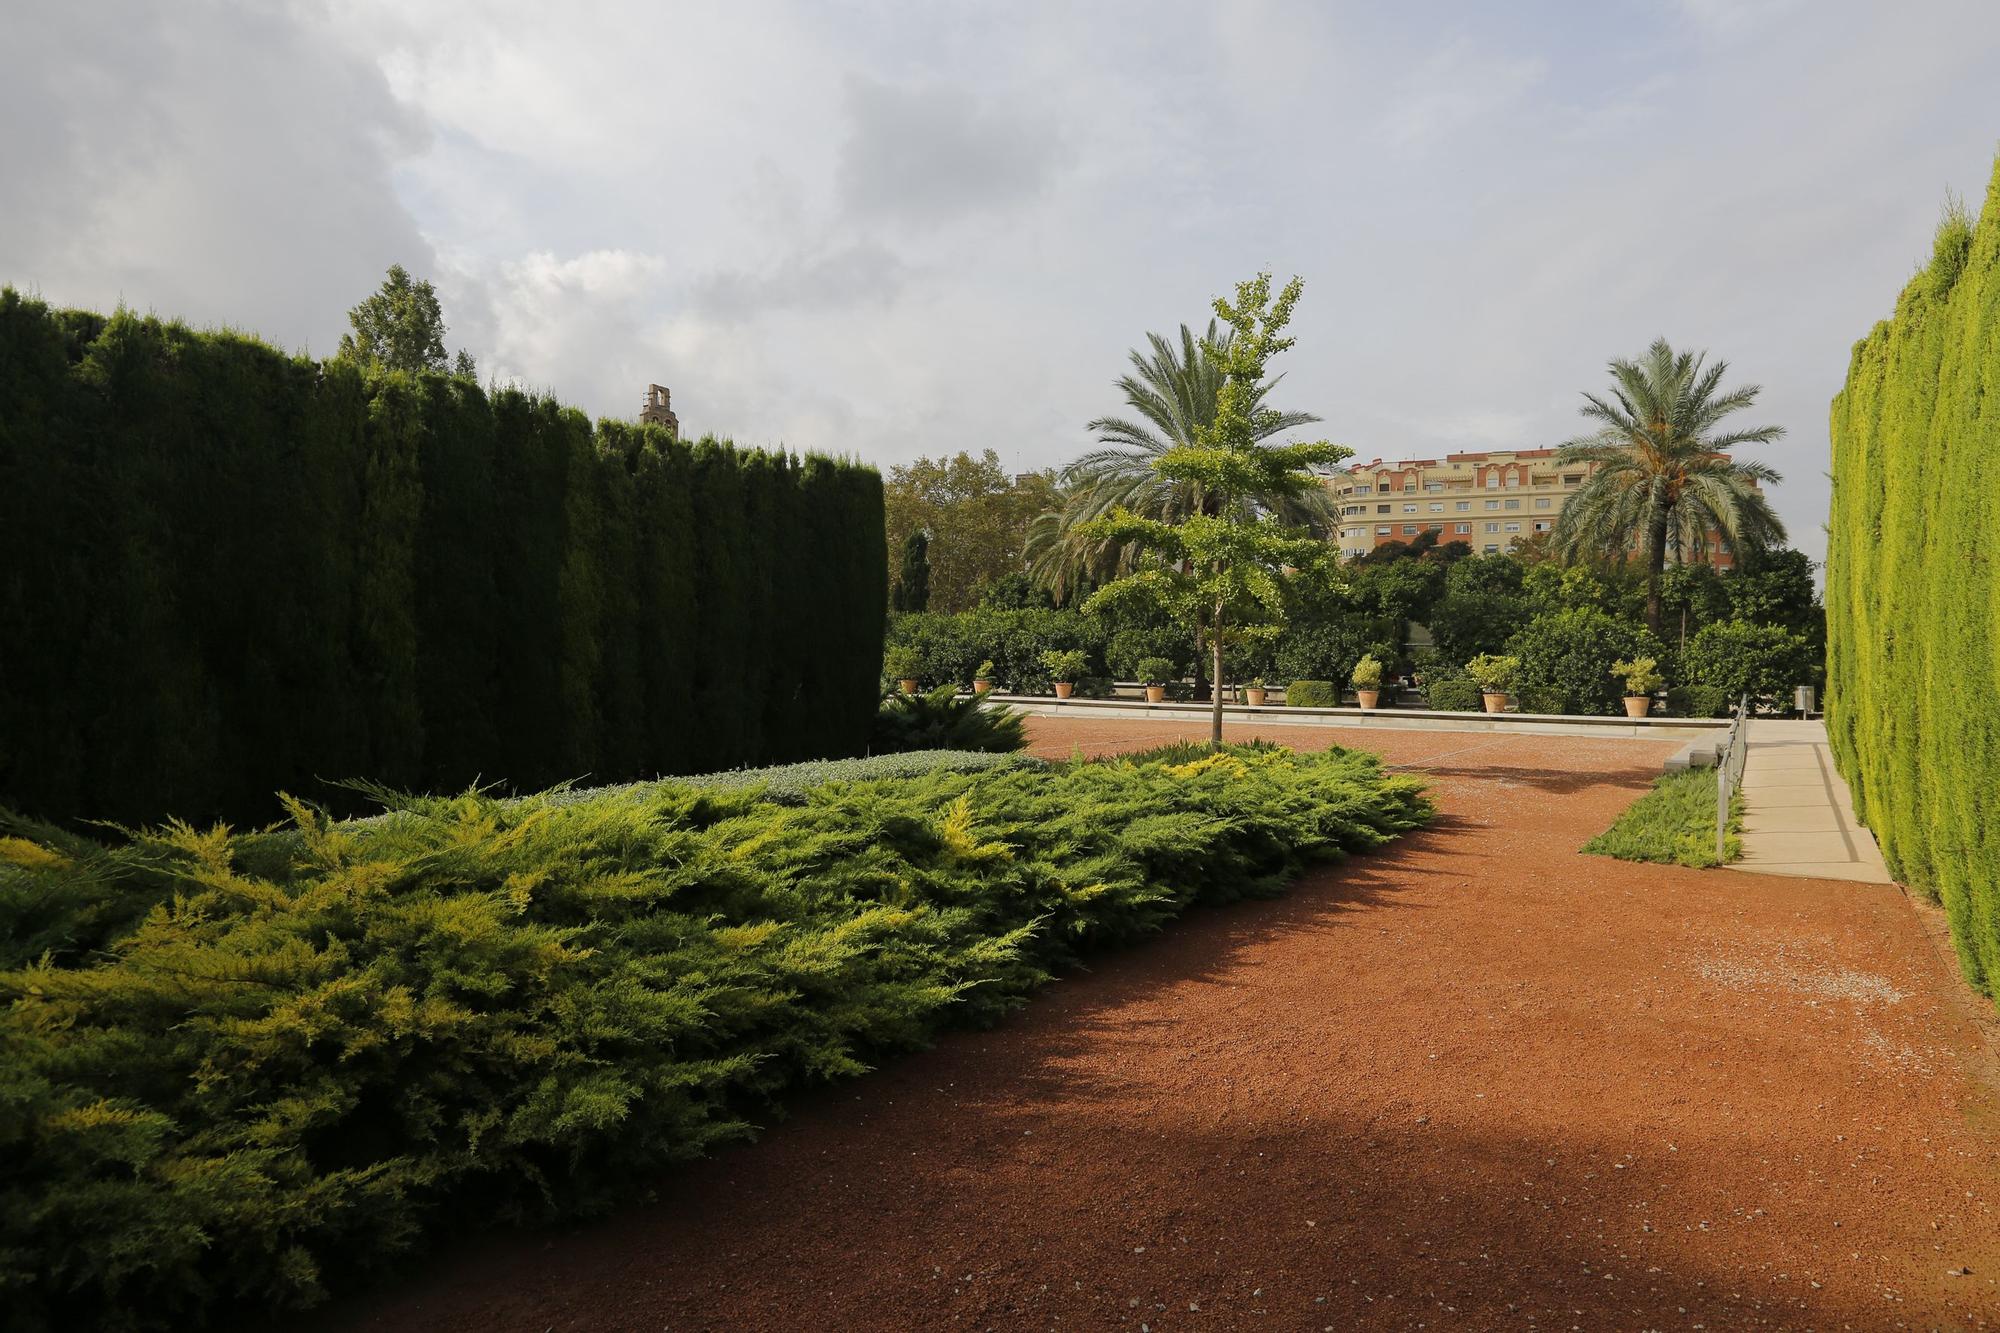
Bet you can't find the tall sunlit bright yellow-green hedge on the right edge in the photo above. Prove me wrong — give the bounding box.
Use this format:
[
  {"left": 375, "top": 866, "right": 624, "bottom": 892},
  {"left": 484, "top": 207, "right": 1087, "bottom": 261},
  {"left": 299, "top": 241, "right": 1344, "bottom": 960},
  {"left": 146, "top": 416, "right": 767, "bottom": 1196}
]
[{"left": 1826, "top": 153, "right": 2000, "bottom": 999}]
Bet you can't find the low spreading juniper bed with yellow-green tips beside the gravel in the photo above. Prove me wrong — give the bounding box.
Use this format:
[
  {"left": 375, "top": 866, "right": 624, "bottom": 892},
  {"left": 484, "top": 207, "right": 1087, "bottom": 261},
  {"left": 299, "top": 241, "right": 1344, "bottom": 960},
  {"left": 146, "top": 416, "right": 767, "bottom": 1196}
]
[{"left": 0, "top": 749, "right": 1428, "bottom": 1331}]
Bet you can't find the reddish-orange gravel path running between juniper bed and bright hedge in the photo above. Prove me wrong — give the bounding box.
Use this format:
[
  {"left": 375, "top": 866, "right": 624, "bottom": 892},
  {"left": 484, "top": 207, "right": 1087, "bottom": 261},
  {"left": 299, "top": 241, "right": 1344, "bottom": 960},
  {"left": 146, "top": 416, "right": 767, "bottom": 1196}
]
[{"left": 326, "top": 719, "right": 2000, "bottom": 1333}]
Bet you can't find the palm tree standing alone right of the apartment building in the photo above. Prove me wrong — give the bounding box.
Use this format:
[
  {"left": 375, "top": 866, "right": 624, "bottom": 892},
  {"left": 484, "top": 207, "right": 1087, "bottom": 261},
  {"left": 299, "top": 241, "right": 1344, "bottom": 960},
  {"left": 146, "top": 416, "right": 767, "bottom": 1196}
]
[{"left": 1550, "top": 338, "right": 1784, "bottom": 634}]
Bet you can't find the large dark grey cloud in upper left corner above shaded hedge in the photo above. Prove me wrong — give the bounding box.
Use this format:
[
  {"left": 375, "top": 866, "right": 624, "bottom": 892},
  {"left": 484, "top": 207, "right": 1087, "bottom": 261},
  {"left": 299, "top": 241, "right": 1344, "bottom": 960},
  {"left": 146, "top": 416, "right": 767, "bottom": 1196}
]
[{"left": 0, "top": 0, "right": 432, "bottom": 352}]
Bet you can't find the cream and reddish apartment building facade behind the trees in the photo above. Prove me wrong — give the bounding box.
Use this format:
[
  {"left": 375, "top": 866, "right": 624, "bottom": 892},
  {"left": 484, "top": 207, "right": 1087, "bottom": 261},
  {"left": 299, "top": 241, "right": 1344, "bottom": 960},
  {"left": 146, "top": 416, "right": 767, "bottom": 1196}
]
[{"left": 1328, "top": 448, "right": 1732, "bottom": 568}]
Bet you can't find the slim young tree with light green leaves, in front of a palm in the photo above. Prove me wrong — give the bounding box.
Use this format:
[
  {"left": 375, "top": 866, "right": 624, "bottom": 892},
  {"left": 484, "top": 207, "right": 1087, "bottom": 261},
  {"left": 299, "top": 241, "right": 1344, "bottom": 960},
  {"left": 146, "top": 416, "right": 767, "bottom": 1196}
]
[{"left": 1084, "top": 272, "right": 1354, "bottom": 745}]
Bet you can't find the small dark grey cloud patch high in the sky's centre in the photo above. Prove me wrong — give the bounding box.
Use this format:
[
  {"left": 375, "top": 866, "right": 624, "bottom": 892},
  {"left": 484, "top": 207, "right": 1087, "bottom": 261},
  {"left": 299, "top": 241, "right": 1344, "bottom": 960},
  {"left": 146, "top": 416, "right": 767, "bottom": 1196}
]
[{"left": 838, "top": 76, "right": 1064, "bottom": 222}]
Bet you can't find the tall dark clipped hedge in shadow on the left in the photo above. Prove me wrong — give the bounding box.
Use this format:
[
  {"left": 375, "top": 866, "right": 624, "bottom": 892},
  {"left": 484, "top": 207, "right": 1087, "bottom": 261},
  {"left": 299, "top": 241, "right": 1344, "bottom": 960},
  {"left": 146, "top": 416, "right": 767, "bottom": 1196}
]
[{"left": 0, "top": 290, "right": 886, "bottom": 823}]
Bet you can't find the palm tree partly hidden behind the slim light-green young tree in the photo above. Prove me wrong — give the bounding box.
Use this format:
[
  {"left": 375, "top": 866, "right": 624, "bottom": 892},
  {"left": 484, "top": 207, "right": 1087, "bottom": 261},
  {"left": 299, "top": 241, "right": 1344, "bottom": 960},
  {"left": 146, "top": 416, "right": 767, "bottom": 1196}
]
[{"left": 1022, "top": 320, "right": 1338, "bottom": 600}]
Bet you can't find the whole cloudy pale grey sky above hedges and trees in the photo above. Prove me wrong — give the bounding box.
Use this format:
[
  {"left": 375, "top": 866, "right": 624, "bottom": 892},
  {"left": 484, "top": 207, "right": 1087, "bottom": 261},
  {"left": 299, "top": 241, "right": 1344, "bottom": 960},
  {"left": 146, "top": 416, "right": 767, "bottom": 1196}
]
[{"left": 0, "top": 0, "right": 2000, "bottom": 558}]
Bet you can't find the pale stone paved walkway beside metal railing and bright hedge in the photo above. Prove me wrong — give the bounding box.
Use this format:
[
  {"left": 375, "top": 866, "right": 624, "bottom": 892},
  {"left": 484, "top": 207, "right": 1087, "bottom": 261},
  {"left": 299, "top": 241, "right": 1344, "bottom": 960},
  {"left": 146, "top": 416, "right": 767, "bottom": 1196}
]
[{"left": 1730, "top": 719, "right": 1896, "bottom": 885}]
